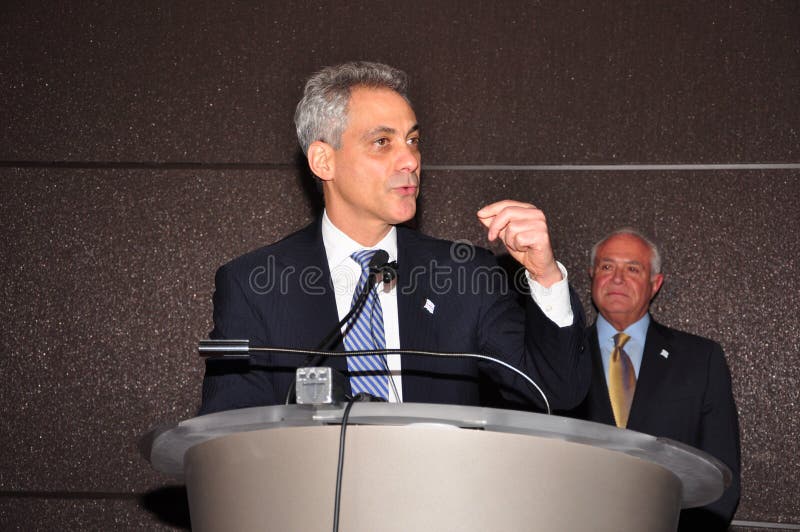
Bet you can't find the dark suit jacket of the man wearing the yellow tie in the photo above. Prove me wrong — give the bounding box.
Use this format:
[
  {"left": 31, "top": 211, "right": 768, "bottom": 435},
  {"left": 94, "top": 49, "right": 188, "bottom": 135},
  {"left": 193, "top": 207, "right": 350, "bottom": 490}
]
[{"left": 571, "top": 319, "right": 740, "bottom": 532}]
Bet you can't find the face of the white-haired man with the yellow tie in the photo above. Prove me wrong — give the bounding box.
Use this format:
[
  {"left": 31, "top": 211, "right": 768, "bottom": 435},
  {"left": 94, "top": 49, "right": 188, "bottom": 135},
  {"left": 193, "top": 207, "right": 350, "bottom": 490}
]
[{"left": 592, "top": 234, "right": 664, "bottom": 331}]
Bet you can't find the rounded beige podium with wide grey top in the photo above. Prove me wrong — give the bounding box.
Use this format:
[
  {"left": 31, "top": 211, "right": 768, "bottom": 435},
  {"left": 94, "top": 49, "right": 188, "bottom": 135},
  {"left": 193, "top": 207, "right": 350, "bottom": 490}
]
[{"left": 142, "top": 403, "right": 731, "bottom": 532}]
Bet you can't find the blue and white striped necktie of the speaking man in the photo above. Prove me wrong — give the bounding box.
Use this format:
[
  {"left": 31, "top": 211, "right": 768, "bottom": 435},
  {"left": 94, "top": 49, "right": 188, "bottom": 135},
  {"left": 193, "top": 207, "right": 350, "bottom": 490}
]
[{"left": 344, "top": 249, "right": 389, "bottom": 400}]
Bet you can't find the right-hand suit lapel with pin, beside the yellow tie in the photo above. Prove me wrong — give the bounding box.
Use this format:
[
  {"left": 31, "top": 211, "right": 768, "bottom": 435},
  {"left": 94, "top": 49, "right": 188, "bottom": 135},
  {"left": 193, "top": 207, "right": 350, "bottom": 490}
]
[{"left": 628, "top": 319, "right": 672, "bottom": 430}]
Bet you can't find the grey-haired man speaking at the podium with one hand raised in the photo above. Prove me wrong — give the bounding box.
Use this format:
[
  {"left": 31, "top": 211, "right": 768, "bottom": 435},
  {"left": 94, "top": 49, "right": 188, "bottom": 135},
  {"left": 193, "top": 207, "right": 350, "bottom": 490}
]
[{"left": 200, "top": 62, "right": 591, "bottom": 414}]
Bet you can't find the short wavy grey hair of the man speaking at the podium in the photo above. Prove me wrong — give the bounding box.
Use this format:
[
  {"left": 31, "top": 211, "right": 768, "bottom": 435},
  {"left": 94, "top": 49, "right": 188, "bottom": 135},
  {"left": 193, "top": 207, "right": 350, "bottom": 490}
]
[{"left": 294, "top": 61, "right": 410, "bottom": 155}]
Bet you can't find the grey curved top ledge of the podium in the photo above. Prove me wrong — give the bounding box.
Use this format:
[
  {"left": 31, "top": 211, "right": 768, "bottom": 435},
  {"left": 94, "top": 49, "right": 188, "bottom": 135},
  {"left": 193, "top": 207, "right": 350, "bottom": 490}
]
[{"left": 140, "top": 402, "right": 731, "bottom": 508}]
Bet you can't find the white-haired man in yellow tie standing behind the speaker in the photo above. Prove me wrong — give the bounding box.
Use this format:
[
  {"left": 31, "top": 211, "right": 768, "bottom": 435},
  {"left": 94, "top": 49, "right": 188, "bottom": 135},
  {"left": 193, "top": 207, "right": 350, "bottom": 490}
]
[{"left": 575, "top": 229, "right": 739, "bottom": 532}]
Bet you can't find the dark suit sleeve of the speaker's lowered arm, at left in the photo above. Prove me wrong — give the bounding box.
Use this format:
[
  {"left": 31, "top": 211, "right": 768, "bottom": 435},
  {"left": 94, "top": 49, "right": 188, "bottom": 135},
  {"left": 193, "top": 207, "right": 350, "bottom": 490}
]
[{"left": 198, "top": 264, "right": 279, "bottom": 415}]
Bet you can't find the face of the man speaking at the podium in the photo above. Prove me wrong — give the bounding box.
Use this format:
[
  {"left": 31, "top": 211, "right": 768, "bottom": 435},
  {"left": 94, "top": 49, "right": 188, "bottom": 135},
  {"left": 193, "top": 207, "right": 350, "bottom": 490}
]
[{"left": 324, "top": 87, "right": 420, "bottom": 241}]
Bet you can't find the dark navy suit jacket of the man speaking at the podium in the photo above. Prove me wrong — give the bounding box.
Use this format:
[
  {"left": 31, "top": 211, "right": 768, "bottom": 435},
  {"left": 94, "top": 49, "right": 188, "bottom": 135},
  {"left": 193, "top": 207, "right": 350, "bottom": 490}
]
[{"left": 200, "top": 220, "right": 591, "bottom": 414}]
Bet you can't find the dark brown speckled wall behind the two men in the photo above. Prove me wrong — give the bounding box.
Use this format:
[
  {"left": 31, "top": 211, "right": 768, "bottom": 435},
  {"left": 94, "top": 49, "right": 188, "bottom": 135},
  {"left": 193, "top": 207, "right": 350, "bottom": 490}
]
[{"left": 0, "top": 0, "right": 800, "bottom": 530}]
